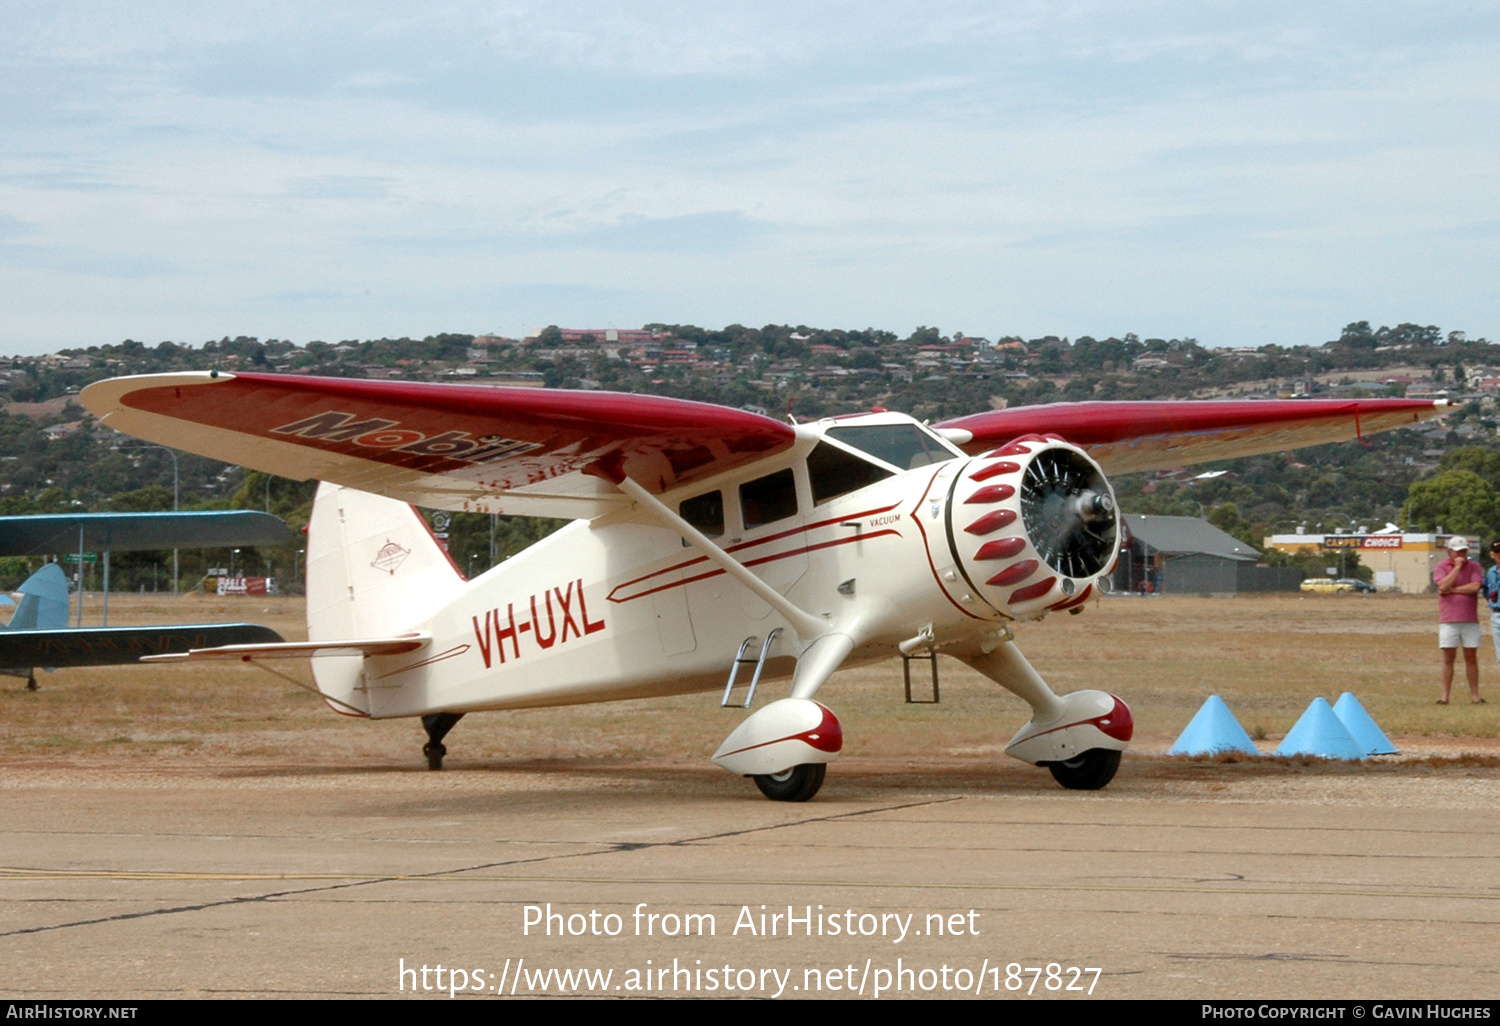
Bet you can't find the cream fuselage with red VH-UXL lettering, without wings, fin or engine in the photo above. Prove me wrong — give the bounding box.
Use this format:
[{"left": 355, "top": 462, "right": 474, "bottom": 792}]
[{"left": 328, "top": 414, "right": 1004, "bottom": 717}]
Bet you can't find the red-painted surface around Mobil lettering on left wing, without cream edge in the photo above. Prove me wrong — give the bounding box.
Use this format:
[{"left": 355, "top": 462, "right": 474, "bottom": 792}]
[{"left": 120, "top": 374, "right": 797, "bottom": 491}]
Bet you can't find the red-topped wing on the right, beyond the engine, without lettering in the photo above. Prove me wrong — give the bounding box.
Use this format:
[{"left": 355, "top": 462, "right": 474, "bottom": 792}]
[{"left": 935, "top": 399, "right": 1452, "bottom": 474}]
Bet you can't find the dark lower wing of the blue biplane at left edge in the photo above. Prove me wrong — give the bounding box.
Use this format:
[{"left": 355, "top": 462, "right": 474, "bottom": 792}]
[{"left": 0, "top": 624, "right": 282, "bottom": 669}]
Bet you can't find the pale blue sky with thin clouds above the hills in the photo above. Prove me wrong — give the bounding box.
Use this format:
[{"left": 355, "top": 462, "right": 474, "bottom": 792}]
[{"left": 0, "top": 0, "right": 1500, "bottom": 354}]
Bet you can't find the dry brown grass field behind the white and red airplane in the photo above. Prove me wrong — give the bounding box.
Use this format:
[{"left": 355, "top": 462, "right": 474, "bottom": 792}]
[{"left": 0, "top": 594, "right": 1500, "bottom": 767}]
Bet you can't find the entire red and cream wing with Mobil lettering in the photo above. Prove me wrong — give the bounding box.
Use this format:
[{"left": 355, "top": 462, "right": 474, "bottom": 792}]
[{"left": 81, "top": 372, "right": 797, "bottom": 519}]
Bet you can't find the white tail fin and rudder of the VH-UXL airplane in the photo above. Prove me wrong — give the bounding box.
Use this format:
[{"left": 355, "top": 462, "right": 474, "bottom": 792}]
[{"left": 308, "top": 483, "right": 465, "bottom": 710}]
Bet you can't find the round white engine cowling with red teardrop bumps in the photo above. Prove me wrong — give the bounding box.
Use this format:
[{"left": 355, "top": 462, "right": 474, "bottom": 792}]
[{"left": 948, "top": 435, "right": 1121, "bottom": 620}]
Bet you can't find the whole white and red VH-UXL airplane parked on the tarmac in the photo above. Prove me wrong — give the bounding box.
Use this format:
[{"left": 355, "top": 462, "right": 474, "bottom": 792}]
[{"left": 83, "top": 372, "right": 1448, "bottom": 801}]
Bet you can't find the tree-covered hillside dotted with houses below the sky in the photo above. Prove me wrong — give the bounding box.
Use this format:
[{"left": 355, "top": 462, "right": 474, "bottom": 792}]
[{"left": 0, "top": 321, "right": 1500, "bottom": 594}]
